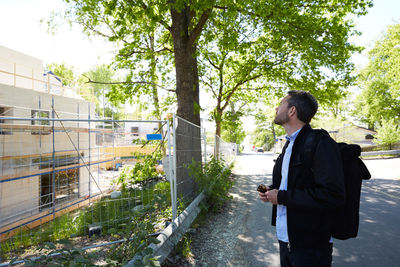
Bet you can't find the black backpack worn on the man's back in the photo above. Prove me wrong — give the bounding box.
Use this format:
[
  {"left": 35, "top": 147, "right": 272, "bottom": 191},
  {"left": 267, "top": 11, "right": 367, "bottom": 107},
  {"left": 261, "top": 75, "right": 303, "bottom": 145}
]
[{"left": 304, "top": 129, "right": 371, "bottom": 240}]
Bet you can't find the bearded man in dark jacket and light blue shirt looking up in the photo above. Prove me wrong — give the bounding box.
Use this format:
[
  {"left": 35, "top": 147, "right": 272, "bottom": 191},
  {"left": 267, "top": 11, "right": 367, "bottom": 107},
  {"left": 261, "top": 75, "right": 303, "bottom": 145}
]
[{"left": 259, "top": 91, "right": 345, "bottom": 267}]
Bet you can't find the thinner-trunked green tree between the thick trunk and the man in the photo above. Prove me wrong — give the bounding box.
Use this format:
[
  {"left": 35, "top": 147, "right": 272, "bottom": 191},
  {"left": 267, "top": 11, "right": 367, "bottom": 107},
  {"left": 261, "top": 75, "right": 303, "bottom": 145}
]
[{"left": 198, "top": 1, "right": 369, "bottom": 154}]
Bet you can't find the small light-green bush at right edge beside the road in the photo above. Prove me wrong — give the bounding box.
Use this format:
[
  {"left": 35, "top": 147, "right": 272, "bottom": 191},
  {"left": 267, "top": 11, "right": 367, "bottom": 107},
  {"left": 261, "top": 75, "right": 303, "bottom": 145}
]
[{"left": 375, "top": 118, "right": 400, "bottom": 149}]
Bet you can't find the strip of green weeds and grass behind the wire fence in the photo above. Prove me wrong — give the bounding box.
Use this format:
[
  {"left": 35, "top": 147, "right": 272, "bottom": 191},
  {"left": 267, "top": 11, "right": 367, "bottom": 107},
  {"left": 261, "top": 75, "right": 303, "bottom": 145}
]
[{"left": 0, "top": 182, "right": 171, "bottom": 261}]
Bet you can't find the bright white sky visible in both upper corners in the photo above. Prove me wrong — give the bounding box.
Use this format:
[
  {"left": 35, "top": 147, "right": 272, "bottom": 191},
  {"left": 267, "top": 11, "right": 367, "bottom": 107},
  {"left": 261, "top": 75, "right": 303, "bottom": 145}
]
[{"left": 0, "top": 0, "right": 400, "bottom": 72}]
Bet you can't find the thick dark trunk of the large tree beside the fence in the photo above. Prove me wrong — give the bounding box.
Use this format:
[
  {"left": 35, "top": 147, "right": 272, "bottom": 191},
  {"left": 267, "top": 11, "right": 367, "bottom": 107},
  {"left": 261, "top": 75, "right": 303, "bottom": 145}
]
[{"left": 171, "top": 7, "right": 201, "bottom": 200}]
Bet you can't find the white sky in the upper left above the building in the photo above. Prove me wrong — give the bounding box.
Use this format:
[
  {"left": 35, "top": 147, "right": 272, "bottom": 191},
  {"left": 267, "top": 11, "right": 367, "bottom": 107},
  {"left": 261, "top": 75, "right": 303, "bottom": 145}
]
[{"left": 0, "top": 0, "right": 113, "bottom": 72}]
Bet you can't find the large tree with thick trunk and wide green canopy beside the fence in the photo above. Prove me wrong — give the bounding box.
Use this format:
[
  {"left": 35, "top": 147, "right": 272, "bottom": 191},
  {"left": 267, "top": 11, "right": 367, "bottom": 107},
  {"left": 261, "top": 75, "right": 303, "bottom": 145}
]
[{"left": 58, "top": 0, "right": 371, "bottom": 198}]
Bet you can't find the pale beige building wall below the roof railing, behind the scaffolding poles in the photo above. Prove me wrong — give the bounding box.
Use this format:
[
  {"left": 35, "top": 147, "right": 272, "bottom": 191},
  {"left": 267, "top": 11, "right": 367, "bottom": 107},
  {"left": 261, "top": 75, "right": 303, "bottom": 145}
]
[{"left": 0, "top": 83, "right": 96, "bottom": 226}]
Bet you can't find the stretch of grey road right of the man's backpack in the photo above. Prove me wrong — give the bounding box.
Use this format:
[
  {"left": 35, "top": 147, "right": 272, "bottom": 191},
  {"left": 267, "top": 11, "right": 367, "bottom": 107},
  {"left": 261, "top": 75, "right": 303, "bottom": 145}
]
[{"left": 333, "top": 158, "right": 400, "bottom": 267}]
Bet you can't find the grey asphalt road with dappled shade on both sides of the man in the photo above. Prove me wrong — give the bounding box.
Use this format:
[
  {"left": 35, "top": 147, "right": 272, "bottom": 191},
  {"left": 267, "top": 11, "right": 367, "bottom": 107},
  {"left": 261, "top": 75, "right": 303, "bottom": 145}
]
[{"left": 180, "top": 152, "right": 400, "bottom": 267}]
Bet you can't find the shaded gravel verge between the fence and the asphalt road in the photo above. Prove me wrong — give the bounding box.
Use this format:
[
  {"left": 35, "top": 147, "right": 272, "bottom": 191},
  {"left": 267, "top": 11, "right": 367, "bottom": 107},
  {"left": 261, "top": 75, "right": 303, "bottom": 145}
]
[{"left": 163, "top": 175, "right": 253, "bottom": 267}]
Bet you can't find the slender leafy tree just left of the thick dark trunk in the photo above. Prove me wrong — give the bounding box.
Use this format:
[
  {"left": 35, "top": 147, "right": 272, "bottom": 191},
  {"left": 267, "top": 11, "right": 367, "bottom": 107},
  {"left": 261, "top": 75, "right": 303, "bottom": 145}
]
[{"left": 108, "top": 30, "right": 176, "bottom": 120}]
